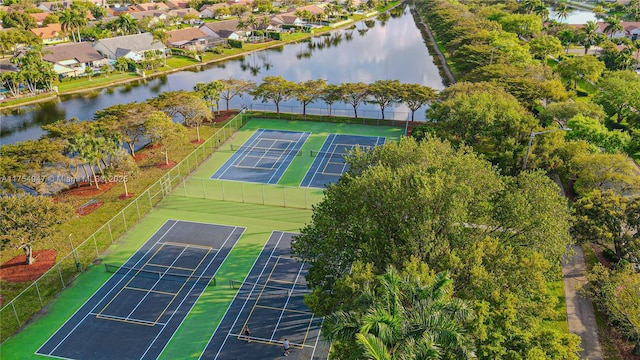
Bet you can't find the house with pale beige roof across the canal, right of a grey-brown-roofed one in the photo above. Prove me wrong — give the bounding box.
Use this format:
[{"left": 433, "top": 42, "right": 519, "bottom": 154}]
[{"left": 93, "top": 33, "right": 166, "bottom": 61}]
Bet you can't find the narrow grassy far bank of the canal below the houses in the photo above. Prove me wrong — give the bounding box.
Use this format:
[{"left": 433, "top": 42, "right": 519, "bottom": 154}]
[{"left": 0, "top": 5, "right": 406, "bottom": 112}]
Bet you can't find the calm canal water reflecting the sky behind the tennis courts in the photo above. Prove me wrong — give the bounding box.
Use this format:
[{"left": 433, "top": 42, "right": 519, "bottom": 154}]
[{"left": 0, "top": 5, "right": 444, "bottom": 143}]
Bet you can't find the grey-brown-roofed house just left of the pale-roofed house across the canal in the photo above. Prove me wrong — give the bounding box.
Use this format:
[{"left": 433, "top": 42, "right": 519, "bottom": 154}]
[{"left": 42, "top": 42, "right": 109, "bottom": 78}]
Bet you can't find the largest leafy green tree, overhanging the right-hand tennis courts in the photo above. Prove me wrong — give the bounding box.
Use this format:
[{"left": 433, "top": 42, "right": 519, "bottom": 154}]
[{"left": 292, "top": 138, "right": 577, "bottom": 359}]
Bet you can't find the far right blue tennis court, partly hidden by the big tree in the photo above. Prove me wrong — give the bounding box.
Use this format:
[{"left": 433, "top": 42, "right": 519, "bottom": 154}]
[{"left": 300, "top": 134, "right": 385, "bottom": 188}]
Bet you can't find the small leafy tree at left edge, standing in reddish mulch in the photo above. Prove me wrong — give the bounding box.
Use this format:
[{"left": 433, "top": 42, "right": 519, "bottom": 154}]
[{"left": 0, "top": 194, "right": 73, "bottom": 265}]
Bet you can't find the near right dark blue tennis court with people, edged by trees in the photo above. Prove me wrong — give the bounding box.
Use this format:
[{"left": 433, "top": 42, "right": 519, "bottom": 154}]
[{"left": 200, "top": 231, "right": 328, "bottom": 359}]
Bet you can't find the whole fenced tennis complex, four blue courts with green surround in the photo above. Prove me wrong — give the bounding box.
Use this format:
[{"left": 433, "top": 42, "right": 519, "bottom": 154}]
[{"left": 2, "top": 119, "right": 402, "bottom": 360}]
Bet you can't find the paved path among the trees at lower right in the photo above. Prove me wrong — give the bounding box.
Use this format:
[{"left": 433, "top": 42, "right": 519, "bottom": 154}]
[{"left": 562, "top": 246, "right": 602, "bottom": 360}]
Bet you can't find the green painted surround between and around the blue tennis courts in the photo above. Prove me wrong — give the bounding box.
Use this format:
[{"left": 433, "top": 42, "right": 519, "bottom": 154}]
[{"left": 0, "top": 119, "right": 403, "bottom": 359}]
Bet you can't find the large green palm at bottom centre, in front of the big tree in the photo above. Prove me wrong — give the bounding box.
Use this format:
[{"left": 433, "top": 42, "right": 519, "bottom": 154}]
[{"left": 325, "top": 267, "right": 474, "bottom": 359}]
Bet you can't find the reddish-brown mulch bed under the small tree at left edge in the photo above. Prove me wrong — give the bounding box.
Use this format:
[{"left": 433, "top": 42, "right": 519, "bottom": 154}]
[{"left": 0, "top": 249, "right": 56, "bottom": 282}]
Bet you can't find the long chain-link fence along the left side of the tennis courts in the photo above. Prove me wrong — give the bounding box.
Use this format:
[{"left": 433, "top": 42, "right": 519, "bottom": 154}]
[{"left": 0, "top": 110, "right": 249, "bottom": 342}]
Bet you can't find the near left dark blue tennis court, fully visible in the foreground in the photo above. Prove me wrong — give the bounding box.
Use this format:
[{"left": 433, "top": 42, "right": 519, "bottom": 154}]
[{"left": 36, "top": 220, "right": 244, "bottom": 360}]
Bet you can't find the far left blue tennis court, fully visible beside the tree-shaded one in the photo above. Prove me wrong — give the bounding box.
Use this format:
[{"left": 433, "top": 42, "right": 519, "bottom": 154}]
[{"left": 211, "top": 129, "right": 309, "bottom": 184}]
